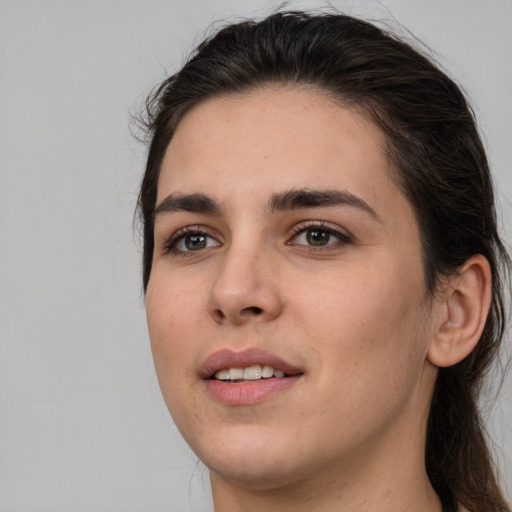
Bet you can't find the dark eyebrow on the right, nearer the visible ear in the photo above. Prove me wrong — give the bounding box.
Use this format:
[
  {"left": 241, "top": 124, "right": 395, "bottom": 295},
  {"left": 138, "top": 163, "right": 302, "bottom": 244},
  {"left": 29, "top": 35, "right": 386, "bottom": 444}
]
[{"left": 269, "top": 189, "right": 381, "bottom": 222}]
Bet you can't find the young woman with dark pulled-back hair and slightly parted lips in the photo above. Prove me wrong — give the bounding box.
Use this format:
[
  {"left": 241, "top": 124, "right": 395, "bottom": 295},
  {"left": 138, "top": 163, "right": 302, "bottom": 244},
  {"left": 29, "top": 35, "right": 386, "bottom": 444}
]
[{"left": 139, "top": 12, "right": 508, "bottom": 512}]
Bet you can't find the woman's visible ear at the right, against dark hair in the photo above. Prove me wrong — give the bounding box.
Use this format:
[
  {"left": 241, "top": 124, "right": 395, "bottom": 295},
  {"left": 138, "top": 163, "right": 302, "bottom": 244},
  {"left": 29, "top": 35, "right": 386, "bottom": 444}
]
[{"left": 427, "top": 254, "right": 492, "bottom": 367}]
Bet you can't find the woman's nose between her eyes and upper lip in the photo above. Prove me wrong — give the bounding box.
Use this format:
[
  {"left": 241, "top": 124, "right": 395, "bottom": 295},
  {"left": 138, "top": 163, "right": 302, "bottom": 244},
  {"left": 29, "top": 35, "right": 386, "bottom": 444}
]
[{"left": 207, "top": 245, "right": 283, "bottom": 325}]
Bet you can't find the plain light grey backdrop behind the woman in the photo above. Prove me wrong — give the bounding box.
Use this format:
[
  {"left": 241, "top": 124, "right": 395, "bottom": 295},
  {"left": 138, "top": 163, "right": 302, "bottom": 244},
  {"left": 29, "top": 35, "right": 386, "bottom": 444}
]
[{"left": 0, "top": 0, "right": 512, "bottom": 512}]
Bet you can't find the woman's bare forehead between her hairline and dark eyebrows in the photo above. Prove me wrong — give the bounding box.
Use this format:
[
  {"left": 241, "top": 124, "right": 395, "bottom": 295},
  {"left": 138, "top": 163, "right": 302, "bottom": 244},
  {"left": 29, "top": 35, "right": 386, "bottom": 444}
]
[{"left": 157, "top": 88, "right": 398, "bottom": 215}]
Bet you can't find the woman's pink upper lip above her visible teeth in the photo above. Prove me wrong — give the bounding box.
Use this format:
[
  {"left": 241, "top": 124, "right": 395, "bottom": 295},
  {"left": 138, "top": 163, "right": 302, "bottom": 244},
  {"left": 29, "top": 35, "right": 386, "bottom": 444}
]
[{"left": 199, "top": 348, "right": 302, "bottom": 379}]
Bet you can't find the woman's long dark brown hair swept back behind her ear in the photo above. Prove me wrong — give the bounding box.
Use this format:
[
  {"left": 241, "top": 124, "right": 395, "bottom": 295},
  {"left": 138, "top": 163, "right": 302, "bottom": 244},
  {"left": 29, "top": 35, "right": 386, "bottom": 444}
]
[{"left": 137, "top": 11, "right": 510, "bottom": 512}]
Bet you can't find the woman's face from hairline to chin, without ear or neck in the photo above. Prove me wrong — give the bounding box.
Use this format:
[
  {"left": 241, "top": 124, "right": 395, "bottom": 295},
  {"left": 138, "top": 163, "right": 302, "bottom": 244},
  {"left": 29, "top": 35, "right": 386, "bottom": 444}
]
[{"left": 147, "top": 88, "right": 435, "bottom": 488}]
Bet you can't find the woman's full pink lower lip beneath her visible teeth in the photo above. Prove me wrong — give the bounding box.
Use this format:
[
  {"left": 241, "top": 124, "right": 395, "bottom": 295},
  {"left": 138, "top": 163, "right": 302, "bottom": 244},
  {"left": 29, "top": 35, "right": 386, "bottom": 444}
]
[{"left": 205, "top": 375, "right": 301, "bottom": 405}]
